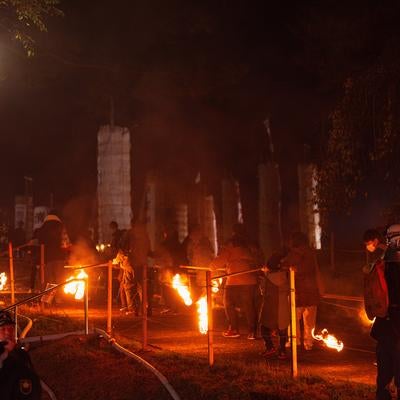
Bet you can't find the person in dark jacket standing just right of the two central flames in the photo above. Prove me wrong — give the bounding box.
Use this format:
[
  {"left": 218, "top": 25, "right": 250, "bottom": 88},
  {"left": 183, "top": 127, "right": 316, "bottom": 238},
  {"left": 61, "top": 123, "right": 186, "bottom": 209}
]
[{"left": 211, "top": 224, "right": 261, "bottom": 339}]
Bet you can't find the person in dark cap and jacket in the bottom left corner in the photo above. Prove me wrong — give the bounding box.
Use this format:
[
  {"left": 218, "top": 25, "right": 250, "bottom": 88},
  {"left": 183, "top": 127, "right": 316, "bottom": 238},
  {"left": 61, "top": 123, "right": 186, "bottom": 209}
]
[{"left": 0, "top": 311, "right": 42, "bottom": 400}]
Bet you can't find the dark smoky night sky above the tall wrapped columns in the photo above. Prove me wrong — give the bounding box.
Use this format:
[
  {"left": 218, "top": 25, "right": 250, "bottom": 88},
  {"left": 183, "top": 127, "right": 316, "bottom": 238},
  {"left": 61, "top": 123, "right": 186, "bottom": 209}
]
[{"left": 0, "top": 0, "right": 398, "bottom": 241}]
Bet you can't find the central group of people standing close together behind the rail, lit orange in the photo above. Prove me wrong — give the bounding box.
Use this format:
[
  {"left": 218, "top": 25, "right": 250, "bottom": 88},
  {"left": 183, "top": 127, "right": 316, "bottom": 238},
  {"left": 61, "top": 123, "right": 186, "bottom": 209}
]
[{"left": 106, "top": 217, "right": 320, "bottom": 359}]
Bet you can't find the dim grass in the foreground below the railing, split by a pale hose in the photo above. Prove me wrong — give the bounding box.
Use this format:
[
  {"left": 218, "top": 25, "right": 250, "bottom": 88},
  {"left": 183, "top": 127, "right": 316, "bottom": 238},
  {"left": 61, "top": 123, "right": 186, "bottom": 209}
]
[{"left": 31, "top": 336, "right": 374, "bottom": 400}]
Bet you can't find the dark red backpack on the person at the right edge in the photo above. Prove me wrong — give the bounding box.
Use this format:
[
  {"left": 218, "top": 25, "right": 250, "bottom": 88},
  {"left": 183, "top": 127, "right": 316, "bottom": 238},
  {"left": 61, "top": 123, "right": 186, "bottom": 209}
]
[{"left": 364, "top": 259, "right": 389, "bottom": 320}]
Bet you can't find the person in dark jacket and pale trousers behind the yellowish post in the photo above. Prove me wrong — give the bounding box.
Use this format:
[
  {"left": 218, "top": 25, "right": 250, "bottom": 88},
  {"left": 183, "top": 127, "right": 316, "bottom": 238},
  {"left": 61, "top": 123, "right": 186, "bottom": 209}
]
[{"left": 283, "top": 232, "right": 320, "bottom": 350}]
